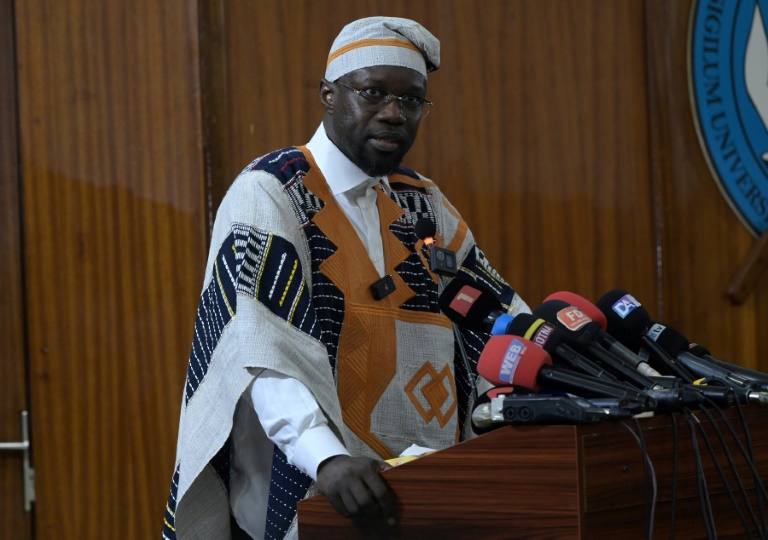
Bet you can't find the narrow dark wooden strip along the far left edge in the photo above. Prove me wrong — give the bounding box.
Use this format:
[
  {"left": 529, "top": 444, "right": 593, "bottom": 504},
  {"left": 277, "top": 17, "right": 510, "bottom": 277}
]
[{"left": 0, "top": 0, "right": 32, "bottom": 539}]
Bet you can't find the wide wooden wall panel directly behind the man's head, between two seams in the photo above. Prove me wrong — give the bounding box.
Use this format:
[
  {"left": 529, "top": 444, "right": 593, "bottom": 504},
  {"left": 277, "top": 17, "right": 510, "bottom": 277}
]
[{"left": 219, "top": 0, "right": 658, "bottom": 310}]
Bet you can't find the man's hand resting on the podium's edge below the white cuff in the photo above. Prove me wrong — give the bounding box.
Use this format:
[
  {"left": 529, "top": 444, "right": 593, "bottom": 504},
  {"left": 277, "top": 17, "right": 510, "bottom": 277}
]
[{"left": 317, "top": 455, "right": 395, "bottom": 525}]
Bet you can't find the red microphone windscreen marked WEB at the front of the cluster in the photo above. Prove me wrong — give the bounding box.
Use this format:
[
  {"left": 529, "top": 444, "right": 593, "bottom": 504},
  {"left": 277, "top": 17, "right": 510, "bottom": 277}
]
[{"left": 477, "top": 336, "right": 552, "bottom": 391}]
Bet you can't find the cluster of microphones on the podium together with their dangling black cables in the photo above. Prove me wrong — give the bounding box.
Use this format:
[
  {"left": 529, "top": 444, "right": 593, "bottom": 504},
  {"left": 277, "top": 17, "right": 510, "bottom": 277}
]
[{"left": 439, "top": 278, "right": 768, "bottom": 540}]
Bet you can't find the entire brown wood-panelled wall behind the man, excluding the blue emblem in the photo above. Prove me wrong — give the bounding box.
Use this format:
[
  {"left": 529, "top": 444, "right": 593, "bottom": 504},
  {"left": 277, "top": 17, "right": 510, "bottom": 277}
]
[{"left": 6, "top": 0, "right": 768, "bottom": 539}]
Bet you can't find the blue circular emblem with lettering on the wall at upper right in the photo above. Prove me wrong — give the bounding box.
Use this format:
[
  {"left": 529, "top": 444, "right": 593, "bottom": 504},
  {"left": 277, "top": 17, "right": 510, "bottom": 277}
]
[{"left": 689, "top": 0, "right": 768, "bottom": 235}]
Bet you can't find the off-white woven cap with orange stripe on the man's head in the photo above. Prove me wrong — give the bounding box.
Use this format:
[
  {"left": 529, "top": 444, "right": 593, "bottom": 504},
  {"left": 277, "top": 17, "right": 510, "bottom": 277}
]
[{"left": 325, "top": 17, "right": 440, "bottom": 82}]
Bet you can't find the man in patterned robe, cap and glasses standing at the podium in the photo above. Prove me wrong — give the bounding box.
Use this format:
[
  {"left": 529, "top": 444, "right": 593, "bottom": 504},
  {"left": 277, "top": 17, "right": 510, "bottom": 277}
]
[{"left": 163, "top": 17, "right": 529, "bottom": 539}]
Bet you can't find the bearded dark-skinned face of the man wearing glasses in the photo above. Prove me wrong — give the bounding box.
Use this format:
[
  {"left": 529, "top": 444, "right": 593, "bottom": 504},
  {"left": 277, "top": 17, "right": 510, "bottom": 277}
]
[{"left": 320, "top": 66, "right": 427, "bottom": 176}]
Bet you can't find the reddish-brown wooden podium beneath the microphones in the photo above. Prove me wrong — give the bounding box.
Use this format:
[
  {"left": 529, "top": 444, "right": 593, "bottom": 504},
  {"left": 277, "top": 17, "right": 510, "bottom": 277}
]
[{"left": 298, "top": 406, "right": 768, "bottom": 540}]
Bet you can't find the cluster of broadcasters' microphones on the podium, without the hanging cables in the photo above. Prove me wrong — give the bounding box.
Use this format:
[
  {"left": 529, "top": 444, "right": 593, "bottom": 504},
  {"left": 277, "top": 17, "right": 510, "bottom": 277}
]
[{"left": 439, "top": 278, "right": 768, "bottom": 429}]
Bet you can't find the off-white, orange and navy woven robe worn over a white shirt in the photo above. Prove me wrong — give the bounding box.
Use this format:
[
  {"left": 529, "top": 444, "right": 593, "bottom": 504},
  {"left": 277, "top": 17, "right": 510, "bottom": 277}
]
[{"left": 163, "top": 147, "right": 528, "bottom": 539}]
